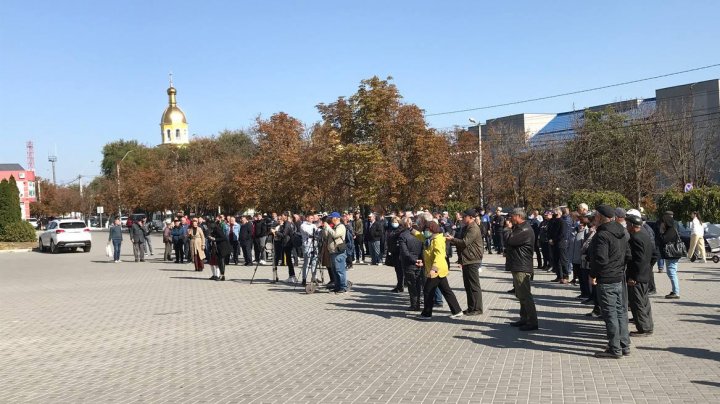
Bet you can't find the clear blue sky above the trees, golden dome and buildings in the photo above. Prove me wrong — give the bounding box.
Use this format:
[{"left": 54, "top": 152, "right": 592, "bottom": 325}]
[{"left": 0, "top": 0, "right": 720, "bottom": 182}]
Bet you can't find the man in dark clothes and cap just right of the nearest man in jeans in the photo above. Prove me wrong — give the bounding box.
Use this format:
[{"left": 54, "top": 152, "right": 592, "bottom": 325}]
[{"left": 625, "top": 215, "right": 655, "bottom": 337}]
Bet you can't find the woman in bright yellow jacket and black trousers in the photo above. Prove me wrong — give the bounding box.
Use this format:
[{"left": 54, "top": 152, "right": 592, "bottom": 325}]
[{"left": 418, "top": 222, "right": 463, "bottom": 320}]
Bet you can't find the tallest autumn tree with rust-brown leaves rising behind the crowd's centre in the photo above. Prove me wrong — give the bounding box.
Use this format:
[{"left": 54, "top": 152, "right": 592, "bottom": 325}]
[{"left": 317, "top": 77, "right": 450, "bottom": 208}]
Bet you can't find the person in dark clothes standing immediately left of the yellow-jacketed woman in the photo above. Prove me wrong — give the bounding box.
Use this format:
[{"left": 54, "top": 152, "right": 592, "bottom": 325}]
[{"left": 398, "top": 217, "right": 425, "bottom": 311}]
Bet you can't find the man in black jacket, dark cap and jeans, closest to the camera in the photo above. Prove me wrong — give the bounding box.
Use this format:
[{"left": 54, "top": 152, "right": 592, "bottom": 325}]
[{"left": 588, "top": 204, "right": 630, "bottom": 359}]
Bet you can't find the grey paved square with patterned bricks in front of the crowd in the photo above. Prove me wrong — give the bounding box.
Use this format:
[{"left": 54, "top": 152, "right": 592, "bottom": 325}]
[{"left": 0, "top": 233, "right": 720, "bottom": 403}]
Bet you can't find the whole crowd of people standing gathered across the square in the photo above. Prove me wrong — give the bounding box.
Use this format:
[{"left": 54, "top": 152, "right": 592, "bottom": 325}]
[{"left": 108, "top": 204, "right": 706, "bottom": 358}]
